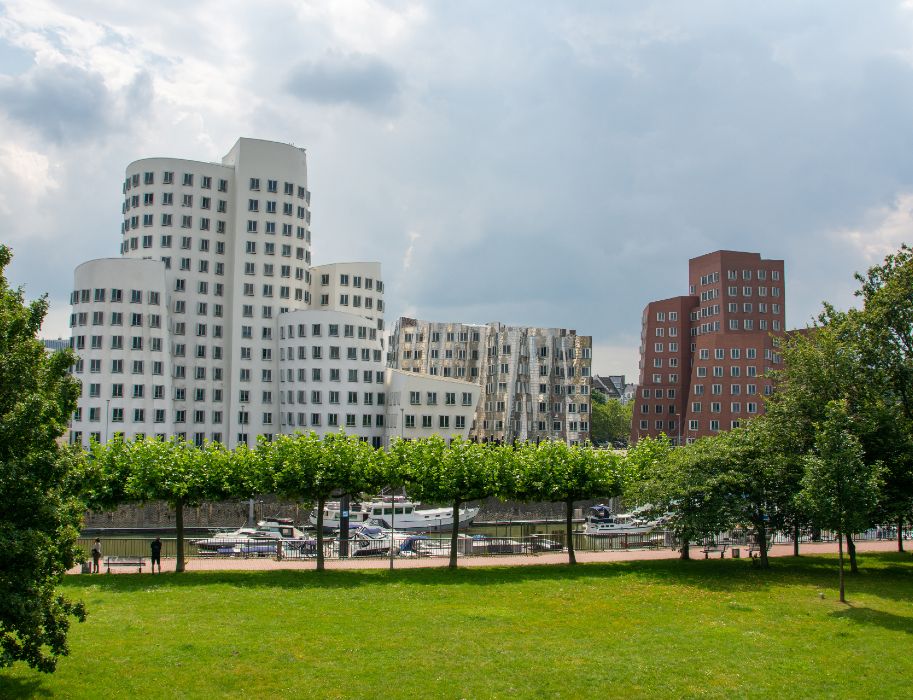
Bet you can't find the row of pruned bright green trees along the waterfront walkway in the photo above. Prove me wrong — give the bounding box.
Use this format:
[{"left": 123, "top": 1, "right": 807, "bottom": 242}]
[{"left": 82, "top": 432, "right": 626, "bottom": 572}]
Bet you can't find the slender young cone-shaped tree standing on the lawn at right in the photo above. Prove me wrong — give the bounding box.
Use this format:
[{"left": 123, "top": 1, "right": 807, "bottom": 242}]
[{"left": 802, "top": 401, "right": 880, "bottom": 603}]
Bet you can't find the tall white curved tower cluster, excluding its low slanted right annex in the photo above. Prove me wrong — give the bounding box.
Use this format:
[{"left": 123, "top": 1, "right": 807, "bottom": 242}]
[{"left": 70, "top": 139, "right": 475, "bottom": 447}]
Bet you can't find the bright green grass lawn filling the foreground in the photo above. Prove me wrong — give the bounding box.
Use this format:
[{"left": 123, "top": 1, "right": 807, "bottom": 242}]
[{"left": 0, "top": 554, "right": 913, "bottom": 700}]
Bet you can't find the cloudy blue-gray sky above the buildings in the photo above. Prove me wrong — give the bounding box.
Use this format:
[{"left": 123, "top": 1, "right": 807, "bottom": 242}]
[{"left": 0, "top": 0, "right": 913, "bottom": 381}]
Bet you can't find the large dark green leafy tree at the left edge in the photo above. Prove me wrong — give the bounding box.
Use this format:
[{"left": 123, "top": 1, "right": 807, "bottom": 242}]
[{"left": 0, "top": 246, "right": 85, "bottom": 673}]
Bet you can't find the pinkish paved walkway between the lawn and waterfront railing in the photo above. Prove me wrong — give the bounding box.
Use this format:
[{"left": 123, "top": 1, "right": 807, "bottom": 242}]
[{"left": 67, "top": 540, "right": 897, "bottom": 576}]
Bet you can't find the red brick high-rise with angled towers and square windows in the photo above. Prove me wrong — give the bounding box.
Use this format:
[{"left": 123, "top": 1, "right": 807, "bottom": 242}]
[{"left": 631, "top": 250, "right": 786, "bottom": 444}]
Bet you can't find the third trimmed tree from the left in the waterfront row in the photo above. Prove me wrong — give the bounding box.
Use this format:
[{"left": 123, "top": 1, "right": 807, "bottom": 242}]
[{"left": 393, "top": 435, "right": 498, "bottom": 569}]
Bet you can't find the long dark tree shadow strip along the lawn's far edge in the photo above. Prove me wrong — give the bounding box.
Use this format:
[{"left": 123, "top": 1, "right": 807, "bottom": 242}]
[{"left": 65, "top": 554, "right": 913, "bottom": 599}]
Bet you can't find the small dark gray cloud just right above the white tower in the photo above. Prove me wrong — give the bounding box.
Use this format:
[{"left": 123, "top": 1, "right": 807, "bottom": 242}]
[{"left": 285, "top": 53, "right": 400, "bottom": 112}]
